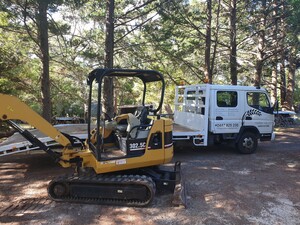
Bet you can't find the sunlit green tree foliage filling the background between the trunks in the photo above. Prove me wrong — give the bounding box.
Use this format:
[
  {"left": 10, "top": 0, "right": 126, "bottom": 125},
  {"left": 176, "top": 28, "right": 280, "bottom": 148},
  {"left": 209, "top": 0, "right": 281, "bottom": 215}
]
[{"left": 0, "top": 0, "right": 300, "bottom": 116}]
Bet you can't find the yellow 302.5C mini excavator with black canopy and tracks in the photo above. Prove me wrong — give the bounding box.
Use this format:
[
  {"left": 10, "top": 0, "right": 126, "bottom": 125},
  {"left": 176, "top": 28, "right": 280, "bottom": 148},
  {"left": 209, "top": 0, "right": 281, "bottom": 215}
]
[{"left": 0, "top": 68, "right": 185, "bottom": 206}]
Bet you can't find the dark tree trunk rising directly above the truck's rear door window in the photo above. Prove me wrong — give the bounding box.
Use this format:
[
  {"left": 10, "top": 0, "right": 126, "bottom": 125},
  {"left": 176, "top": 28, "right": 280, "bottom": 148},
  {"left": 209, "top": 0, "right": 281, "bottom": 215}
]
[{"left": 230, "top": 0, "right": 237, "bottom": 85}]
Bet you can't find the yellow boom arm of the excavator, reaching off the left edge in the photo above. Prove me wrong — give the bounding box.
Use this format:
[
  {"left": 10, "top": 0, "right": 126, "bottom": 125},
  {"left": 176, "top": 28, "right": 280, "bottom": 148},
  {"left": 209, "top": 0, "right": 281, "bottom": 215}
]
[{"left": 0, "top": 94, "right": 71, "bottom": 147}]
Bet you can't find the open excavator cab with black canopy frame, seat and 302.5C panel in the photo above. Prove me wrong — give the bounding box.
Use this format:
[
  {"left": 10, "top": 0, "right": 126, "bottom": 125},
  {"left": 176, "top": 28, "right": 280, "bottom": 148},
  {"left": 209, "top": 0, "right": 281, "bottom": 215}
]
[{"left": 86, "top": 69, "right": 173, "bottom": 164}]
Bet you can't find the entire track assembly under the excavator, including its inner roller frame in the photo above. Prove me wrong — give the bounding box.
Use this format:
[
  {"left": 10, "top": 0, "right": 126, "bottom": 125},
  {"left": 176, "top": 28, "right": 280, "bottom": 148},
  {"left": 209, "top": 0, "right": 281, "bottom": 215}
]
[{"left": 48, "top": 175, "right": 156, "bottom": 207}]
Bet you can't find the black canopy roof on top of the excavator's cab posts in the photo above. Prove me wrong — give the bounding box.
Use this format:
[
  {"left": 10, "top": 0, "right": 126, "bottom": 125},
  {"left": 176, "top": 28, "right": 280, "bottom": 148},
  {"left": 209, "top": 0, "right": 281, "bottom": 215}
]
[{"left": 88, "top": 68, "right": 163, "bottom": 84}]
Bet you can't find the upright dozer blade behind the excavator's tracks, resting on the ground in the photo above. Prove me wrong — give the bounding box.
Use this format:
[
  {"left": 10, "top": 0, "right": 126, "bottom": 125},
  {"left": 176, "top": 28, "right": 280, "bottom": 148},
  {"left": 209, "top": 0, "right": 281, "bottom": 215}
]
[{"left": 172, "top": 161, "right": 187, "bottom": 208}]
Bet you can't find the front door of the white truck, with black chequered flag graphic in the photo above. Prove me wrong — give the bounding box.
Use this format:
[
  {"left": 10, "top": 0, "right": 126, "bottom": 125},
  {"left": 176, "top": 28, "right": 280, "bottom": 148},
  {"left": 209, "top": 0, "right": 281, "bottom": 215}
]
[{"left": 243, "top": 91, "right": 274, "bottom": 134}]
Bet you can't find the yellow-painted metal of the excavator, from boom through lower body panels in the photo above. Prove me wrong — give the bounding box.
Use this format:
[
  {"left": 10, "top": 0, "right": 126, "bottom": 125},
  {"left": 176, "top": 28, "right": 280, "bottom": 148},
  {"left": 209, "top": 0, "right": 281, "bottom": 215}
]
[{"left": 0, "top": 94, "right": 173, "bottom": 173}]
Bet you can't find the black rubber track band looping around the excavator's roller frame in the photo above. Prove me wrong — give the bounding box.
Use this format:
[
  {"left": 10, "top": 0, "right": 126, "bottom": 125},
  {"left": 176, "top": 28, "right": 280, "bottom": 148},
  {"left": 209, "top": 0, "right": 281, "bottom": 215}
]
[{"left": 48, "top": 175, "right": 156, "bottom": 207}]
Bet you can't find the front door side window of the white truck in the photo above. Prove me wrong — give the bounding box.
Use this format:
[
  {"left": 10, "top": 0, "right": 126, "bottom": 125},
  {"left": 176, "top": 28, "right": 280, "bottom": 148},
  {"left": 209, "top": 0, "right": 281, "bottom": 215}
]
[{"left": 247, "top": 92, "right": 271, "bottom": 113}]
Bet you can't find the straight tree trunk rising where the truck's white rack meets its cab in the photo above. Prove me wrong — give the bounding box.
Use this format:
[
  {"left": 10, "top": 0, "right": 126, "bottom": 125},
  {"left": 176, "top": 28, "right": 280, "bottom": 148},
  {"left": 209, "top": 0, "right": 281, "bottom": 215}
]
[{"left": 204, "top": 0, "right": 212, "bottom": 84}]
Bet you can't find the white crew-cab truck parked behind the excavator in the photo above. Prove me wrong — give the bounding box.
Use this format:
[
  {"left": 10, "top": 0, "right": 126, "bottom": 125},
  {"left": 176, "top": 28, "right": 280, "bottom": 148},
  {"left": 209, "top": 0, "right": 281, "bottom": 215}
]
[{"left": 173, "top": 84, "right": 275, "bottom": 154}]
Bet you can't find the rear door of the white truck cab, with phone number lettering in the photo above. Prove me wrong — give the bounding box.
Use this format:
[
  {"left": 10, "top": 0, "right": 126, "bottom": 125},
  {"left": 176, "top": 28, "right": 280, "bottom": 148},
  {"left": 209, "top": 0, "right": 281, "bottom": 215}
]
[{"left": 210, "top": 90, "right": 244, "bottom": 134}]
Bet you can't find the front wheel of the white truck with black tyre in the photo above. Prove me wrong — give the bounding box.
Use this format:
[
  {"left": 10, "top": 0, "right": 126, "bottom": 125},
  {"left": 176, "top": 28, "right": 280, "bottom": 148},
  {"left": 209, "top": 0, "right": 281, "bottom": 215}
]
[{"left": 236, "top": 132, "right": 257, "bottom": 154}]
